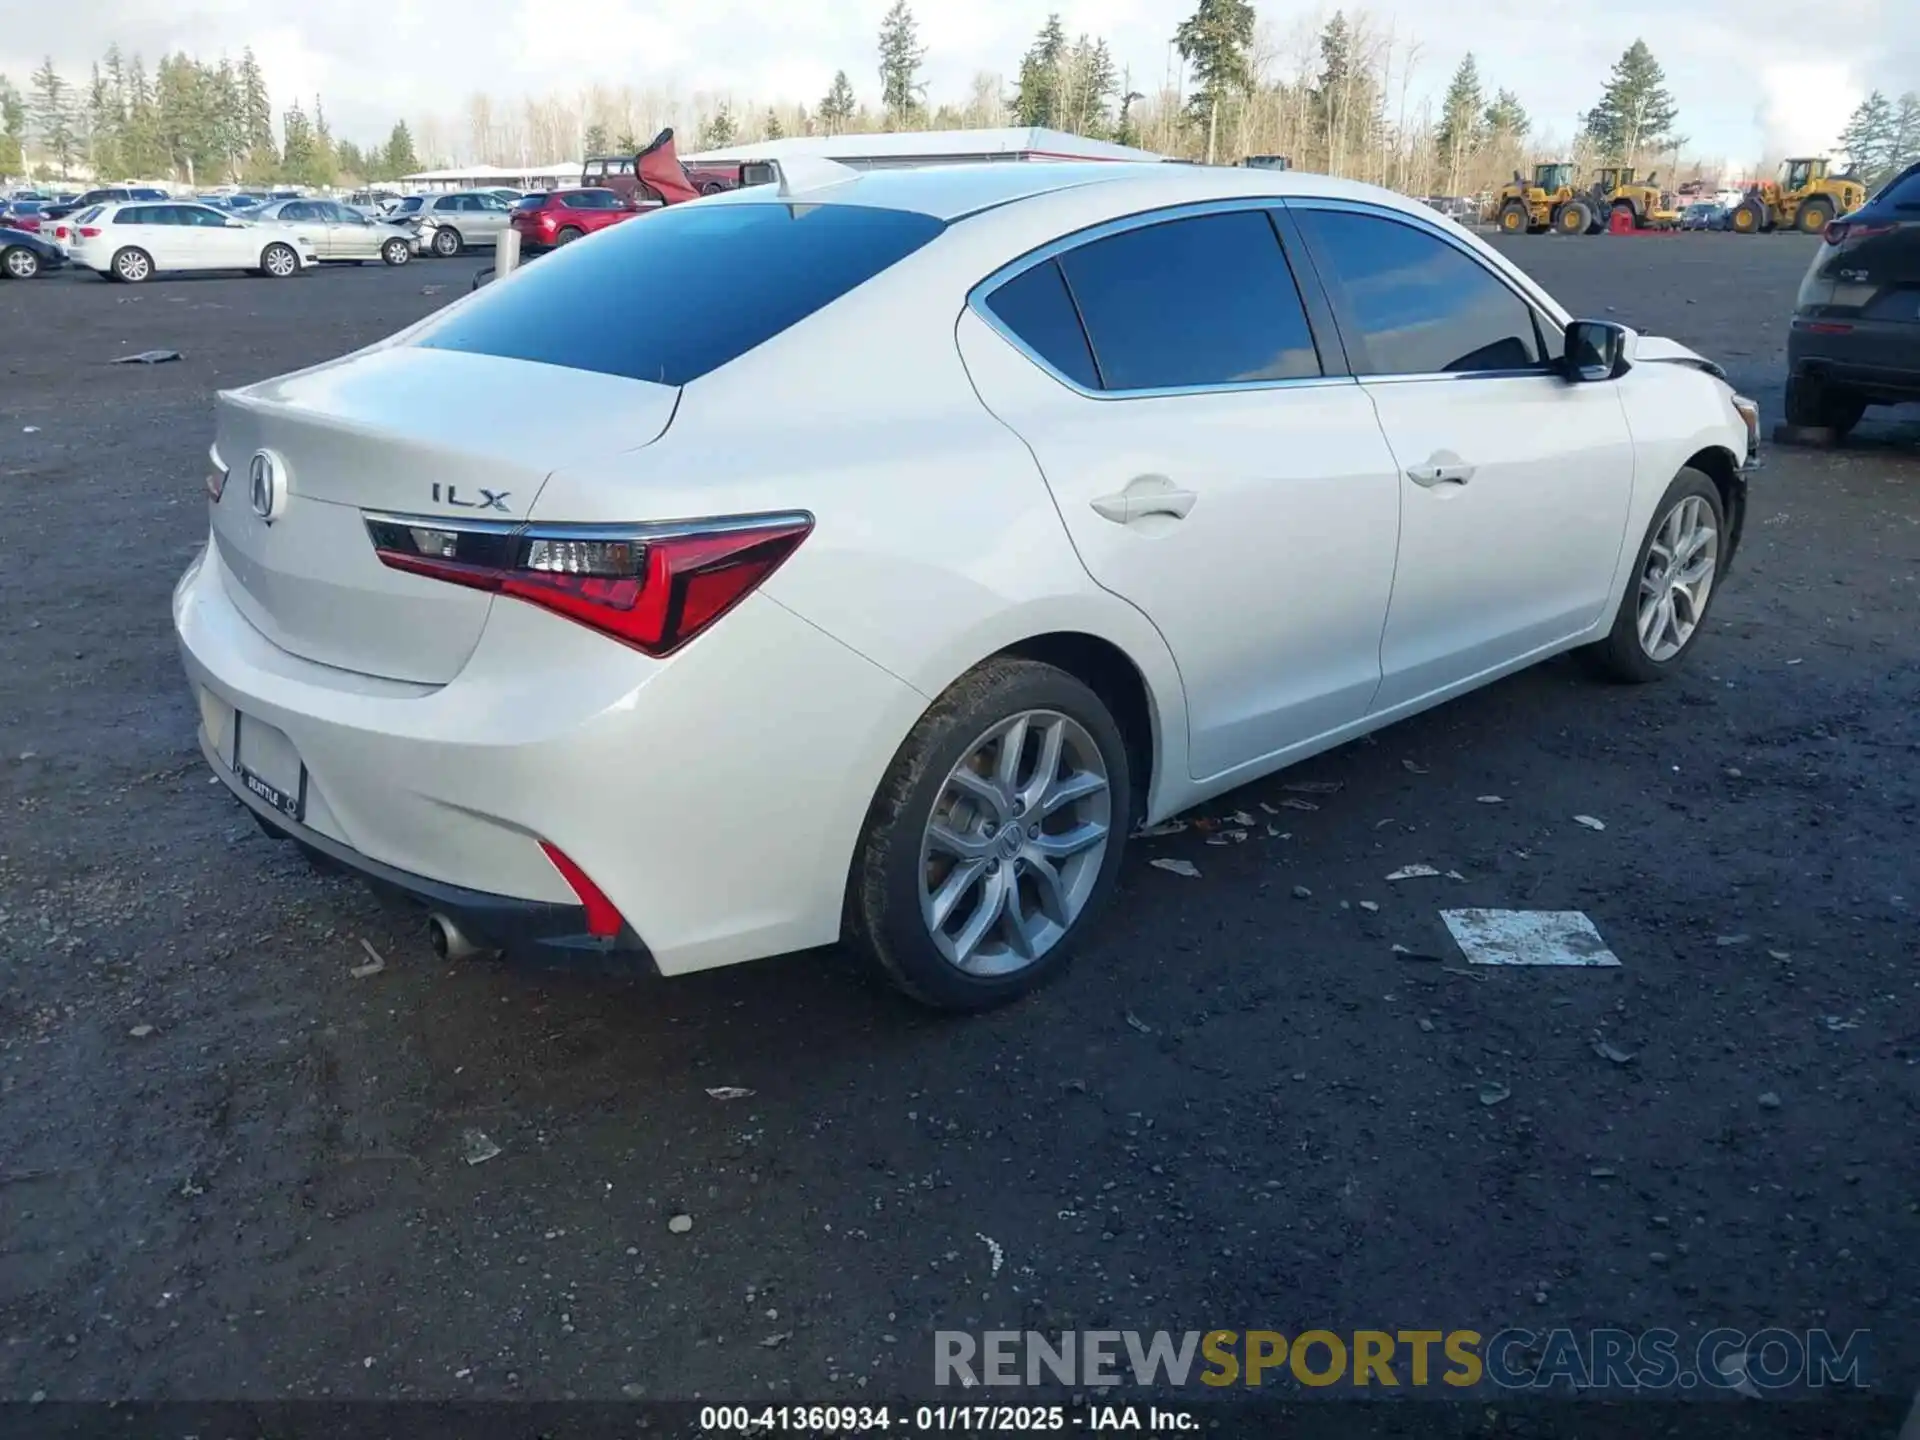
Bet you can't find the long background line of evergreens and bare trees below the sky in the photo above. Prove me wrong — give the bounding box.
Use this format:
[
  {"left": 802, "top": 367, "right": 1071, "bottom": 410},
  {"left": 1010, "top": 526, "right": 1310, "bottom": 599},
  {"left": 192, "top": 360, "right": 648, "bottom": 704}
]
[{"left": 0, "top": 0, "right": 1720, "bottom": 203}]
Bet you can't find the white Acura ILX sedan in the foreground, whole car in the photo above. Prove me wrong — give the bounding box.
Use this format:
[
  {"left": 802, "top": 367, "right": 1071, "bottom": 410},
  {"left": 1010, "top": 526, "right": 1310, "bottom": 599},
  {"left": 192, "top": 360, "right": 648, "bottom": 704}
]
[{"left": 175, "top": 163, "right": 1757, "bottom": 1008}]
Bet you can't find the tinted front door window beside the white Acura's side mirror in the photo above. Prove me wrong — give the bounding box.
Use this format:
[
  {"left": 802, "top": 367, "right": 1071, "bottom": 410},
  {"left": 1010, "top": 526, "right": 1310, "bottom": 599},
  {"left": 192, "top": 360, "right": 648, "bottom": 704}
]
[{"left": 1296, "top": 209, "right": 1540, "bottom": 374}]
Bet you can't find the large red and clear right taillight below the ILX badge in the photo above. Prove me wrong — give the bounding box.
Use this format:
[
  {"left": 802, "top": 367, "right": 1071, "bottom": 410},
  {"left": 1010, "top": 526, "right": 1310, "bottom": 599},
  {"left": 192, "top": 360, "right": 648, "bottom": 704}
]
[{"left": 367, "top": 513, "right": 814, "bottom": 657}]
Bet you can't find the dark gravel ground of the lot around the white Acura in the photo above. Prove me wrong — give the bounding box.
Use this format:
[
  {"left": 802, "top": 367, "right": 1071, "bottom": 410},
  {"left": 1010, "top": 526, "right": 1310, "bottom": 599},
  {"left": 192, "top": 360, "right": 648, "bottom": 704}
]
[{"left": 0, "top": 236, "right": 1920, "bottom": 1400}]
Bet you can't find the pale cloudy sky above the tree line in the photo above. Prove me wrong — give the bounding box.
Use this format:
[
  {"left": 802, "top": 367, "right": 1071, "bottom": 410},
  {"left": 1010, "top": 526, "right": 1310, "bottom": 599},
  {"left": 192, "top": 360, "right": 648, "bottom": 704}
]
[{"left": 0, "top": 0, "right": 1920, "bottom": 159}]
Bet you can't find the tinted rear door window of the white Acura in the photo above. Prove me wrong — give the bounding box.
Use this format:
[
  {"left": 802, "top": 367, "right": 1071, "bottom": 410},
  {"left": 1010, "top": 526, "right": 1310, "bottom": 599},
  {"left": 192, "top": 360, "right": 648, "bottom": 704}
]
[{"left": 1060, "top": 209, "right": 1321, "bottom": 390}]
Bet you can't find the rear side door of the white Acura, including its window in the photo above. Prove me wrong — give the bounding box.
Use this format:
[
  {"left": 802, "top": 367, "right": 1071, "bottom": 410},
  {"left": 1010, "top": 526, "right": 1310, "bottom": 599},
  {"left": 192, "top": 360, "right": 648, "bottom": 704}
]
[{"left": 960, "top": 205, "right": 1400, "bottom": 778}]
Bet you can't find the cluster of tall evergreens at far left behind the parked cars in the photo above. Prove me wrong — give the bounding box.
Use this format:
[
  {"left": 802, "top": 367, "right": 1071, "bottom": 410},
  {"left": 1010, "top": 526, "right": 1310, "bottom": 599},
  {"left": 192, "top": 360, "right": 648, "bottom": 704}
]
[{"left": 0, "top": 46, "right": 420, "bottom": 186}]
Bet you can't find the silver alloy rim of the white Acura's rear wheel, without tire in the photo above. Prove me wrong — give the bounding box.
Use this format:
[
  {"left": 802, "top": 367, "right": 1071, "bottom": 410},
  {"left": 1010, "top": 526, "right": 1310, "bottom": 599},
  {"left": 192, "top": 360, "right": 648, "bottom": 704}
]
[{"left": 920, "top": 710, "right": 1114, "bottom": 977}]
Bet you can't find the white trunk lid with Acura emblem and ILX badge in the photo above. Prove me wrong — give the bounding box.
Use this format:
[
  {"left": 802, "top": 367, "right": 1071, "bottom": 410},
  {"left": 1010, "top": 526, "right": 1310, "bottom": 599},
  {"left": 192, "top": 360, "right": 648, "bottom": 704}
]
[{"left": 213, "top": 344, "right": 680, "bottom": 684}]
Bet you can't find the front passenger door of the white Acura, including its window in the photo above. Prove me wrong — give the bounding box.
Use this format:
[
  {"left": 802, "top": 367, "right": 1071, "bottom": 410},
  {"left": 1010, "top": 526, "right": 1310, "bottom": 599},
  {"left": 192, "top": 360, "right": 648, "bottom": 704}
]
[{"left": 1288, "top": 202, "right": 1634, "bottom": 710}]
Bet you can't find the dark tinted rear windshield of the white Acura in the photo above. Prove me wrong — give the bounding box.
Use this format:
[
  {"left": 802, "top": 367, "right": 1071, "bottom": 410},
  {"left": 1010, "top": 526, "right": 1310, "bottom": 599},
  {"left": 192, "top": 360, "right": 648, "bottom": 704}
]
[{"left": 417, "top": 204, "right": 947, "bottom": 386}]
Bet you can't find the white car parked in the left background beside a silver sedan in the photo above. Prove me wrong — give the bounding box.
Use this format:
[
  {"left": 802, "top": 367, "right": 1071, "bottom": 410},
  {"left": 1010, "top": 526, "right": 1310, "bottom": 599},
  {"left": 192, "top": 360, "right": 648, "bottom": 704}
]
[{"left": 67, "top": 200, "right": 319, "bottom": 284}]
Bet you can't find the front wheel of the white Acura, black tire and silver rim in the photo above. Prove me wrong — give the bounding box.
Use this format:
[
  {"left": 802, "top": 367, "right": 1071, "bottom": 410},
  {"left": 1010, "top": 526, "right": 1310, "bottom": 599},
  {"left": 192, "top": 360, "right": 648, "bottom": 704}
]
[{"left": 1588, "top": 468, "right": 1726, "bottom": 685}]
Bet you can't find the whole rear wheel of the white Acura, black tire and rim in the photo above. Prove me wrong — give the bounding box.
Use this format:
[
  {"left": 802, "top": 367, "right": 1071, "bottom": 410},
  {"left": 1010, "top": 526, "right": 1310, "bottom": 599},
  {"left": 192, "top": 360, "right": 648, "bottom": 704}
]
[{"left": 847, "top": 659, "right": 1133, "bottom": 1010}]
